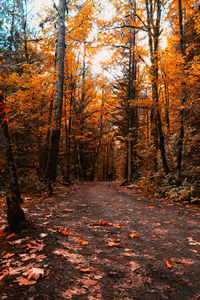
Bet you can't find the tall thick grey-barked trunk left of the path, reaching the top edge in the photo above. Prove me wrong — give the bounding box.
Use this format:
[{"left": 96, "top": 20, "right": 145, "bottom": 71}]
[{"left": 46, "top": 0, "right": 66, "bottom": 194}]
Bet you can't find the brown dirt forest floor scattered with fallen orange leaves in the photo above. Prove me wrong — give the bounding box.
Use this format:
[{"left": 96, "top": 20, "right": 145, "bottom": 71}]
[{"left": 0, "top": 182, "right": 200, "bottom": 300}]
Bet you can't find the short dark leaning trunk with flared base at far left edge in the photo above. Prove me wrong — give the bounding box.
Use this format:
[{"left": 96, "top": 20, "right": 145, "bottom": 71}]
[{"left": 0, "top": 95, "right": 25, "bottom": 232}]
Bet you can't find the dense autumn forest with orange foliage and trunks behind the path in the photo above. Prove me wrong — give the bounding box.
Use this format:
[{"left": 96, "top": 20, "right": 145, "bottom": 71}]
[{"left": 0, "top": 0, "right": 200, "bottom": 210}]
